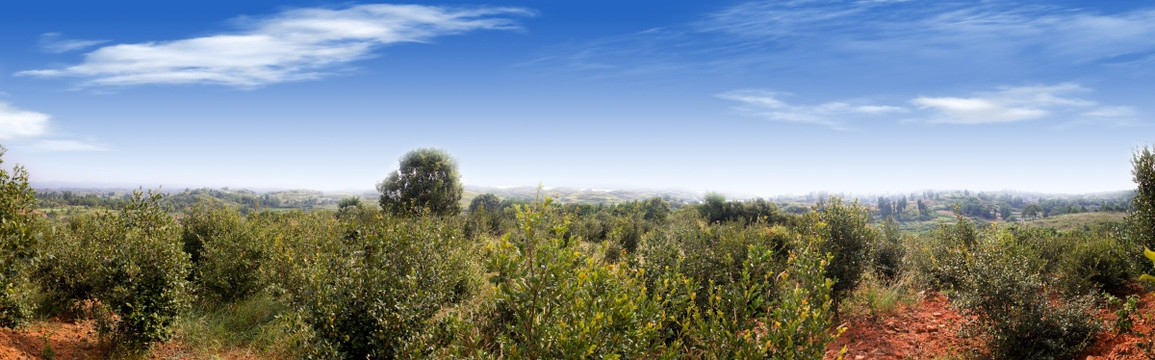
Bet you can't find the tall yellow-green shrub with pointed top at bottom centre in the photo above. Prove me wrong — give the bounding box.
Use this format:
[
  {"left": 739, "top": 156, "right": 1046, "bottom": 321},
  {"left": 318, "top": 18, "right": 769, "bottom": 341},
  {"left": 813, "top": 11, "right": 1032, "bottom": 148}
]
[{"left": 446, "top": 198, "right": 686, "bottom": 359}]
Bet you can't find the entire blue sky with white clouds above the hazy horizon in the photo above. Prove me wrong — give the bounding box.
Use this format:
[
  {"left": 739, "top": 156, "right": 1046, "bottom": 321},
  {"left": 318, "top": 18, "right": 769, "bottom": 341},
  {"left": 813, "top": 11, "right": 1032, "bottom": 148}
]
[{"left": 0, "top": 0, "right": 1155, "bottom": 196}]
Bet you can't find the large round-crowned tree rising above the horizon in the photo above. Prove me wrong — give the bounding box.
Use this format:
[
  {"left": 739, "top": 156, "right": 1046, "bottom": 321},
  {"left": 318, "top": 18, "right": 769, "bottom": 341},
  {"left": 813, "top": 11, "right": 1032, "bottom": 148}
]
[{"left": 377, "top": 149, "right": 462, "bottom": 215}]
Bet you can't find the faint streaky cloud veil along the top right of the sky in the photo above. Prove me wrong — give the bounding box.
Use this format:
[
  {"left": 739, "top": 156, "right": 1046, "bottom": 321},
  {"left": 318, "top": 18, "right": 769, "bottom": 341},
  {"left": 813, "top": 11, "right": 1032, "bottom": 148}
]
[{"left": 537, "top": 0, "right": 1155, "bottom": 78}]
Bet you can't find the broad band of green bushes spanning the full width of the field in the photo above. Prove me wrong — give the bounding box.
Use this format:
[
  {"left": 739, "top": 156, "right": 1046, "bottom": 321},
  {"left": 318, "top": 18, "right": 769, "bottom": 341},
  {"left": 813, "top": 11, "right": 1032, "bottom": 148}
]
[{"left": 0, "top": 145, "right": 1155, "bottom": 359}]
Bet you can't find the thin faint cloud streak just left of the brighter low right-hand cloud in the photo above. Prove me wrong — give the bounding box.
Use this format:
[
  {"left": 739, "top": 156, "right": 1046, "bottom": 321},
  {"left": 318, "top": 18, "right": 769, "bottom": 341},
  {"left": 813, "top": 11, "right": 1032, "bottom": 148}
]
[{"left": 717, "top": 89, "right": 909, "bottom": 130}]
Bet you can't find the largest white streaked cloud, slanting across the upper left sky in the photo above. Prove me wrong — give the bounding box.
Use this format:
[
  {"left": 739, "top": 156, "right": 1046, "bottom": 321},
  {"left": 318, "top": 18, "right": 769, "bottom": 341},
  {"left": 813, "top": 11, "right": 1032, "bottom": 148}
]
[{"left": 17, "top": 5, "right": 532, "bottom": 88}]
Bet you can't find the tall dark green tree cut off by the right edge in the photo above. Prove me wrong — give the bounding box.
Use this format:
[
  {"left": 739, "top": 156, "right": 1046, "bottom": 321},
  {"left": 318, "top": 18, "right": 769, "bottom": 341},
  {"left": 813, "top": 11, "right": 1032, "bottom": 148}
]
[{"left": 1127, "top": 147, "right": 1155, "bottom": 248}]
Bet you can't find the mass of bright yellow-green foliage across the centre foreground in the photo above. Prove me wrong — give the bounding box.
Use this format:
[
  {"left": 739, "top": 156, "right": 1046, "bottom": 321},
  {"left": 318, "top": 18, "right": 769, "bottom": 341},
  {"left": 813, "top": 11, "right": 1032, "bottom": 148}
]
[{"left": 439, "top": 200, "right": 837, "bottom": 359}]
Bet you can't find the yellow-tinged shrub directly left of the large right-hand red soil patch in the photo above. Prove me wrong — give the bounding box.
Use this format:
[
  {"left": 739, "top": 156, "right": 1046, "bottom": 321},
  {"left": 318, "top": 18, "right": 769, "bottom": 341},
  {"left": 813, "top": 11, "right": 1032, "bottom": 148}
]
[{"left": 683, "top": 238, "right": 844, "bottom": 359}]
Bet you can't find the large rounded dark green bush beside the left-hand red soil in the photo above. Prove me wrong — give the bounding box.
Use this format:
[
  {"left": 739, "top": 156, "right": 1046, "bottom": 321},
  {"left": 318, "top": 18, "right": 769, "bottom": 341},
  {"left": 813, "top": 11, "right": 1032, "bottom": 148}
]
[{"left": 37, "top": 192, "right": 189, "bottom": 348}]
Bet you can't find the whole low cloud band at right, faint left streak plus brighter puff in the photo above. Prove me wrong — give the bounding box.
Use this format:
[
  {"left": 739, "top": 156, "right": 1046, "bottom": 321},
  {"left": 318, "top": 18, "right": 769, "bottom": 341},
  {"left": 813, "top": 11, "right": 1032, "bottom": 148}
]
[{"left": 717, "top": 83, "right": 1139, "bottom": 129}]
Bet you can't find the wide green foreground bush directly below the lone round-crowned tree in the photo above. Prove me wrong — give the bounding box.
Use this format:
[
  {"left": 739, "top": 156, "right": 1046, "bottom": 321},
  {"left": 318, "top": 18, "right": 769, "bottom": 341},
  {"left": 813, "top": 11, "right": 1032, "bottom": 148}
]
[{"left": 281, "top": 214, "right": 476, "bottom": 359}]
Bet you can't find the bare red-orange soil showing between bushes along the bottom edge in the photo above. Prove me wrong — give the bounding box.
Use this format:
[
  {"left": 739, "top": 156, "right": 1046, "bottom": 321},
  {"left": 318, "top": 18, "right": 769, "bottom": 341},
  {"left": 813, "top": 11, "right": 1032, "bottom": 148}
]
[{"left": 0, "top": 288, "right": 1155, "bottom": 360}]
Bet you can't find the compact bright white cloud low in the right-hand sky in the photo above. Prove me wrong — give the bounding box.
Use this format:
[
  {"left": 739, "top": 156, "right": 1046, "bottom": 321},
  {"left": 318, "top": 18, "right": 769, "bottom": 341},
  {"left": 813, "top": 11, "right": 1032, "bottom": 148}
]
[{"left": 910, "top": 83, "right": 1097, "bottom": 123}]
